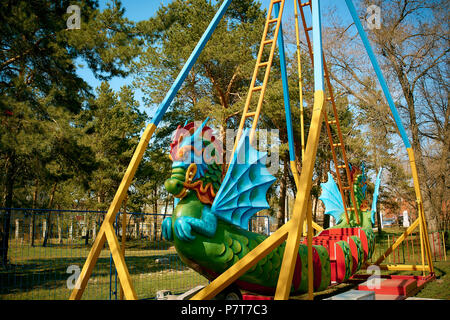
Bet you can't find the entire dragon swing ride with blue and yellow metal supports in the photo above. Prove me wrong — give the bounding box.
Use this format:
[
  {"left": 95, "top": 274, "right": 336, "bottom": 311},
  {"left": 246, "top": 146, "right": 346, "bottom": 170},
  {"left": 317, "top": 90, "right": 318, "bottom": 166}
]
[{"left": 70, "top": 0, "right": 434, "bottom": 300}]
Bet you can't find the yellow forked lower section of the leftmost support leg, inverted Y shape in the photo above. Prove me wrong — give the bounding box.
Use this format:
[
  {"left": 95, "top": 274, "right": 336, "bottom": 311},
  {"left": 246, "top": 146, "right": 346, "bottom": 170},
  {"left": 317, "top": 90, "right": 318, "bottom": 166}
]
[{"left": 69, "top": 123, "right": 156, "bottom": 300}]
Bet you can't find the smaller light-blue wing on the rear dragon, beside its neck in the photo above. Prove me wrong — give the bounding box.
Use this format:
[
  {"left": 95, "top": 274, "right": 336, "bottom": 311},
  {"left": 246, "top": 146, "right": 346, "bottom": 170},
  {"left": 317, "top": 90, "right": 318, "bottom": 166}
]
[{"left": 319, "top": 172, "right": 345, "bottom": 224}]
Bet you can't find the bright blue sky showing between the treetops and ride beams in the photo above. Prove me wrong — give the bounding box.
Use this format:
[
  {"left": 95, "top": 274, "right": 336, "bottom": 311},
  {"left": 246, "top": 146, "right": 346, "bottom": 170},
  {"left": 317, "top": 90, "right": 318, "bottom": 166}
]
[{"left": 78, "top": 0, "right": 356, "bottom": 112}]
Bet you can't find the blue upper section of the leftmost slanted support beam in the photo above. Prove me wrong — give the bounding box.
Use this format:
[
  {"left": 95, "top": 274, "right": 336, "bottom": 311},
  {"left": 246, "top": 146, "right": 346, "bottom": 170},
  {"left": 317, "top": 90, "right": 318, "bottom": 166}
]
[{"left": 151, "top": 0, "right": 232, "bottom": 126}]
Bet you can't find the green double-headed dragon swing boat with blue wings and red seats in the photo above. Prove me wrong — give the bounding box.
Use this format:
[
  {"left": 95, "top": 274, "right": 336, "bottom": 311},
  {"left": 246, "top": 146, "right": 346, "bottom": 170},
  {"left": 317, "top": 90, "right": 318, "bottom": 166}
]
[{"left": 162, "top": 121, "right": 380, "bottom": 294}]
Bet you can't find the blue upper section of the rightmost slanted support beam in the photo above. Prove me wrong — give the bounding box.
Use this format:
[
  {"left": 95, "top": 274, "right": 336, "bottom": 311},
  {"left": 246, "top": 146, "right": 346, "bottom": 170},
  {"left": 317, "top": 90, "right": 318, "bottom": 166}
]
[{"left": 345, "top": 0, "right": 411, "bottom": 148}]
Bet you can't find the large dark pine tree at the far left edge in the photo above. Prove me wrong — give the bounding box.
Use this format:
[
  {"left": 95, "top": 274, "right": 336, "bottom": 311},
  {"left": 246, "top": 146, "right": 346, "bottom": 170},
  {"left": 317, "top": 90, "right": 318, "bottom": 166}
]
[{"left": 0, "top": 0, "right": 139, "bottom": 265}]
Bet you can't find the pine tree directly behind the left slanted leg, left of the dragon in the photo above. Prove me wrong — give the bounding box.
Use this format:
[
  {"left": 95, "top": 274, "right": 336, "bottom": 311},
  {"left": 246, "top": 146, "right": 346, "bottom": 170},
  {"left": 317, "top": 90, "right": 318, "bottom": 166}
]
[{"left": 78, "top": 82, "right": 146, "bottom": 210}]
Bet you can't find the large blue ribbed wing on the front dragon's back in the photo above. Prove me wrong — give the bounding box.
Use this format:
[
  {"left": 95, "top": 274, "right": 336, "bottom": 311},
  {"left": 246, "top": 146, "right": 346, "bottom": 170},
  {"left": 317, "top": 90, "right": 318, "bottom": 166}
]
[{"left": 211, "top": 129, "right": 276, "bottom": 229}]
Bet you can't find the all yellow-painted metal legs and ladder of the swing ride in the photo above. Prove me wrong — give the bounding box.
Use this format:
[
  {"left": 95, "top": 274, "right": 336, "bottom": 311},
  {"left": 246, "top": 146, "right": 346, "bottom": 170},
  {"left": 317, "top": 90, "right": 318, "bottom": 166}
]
[{"left": 70, "top": 0, "right": 433, "bottom": 300}]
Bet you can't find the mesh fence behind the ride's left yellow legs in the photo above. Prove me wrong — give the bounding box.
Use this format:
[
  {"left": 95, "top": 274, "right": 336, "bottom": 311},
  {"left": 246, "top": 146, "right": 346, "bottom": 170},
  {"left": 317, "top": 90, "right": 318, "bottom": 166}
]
[{"left": 0, "top": 208, "right": 270, "bottom": 300}]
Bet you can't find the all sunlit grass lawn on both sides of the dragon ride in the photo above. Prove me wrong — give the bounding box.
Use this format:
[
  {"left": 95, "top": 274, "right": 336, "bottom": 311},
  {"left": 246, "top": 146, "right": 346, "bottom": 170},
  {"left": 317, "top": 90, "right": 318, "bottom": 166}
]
[{"left": 0, "top": 228, "right": 450, "bottom": 300}]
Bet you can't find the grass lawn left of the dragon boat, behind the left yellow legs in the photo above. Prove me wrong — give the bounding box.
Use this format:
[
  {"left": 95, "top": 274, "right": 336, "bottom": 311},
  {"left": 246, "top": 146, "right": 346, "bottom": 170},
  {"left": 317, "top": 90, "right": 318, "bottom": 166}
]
[{"left": 0, "top": 241, "right": 208, "bottom": 300}]
